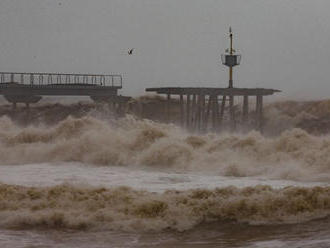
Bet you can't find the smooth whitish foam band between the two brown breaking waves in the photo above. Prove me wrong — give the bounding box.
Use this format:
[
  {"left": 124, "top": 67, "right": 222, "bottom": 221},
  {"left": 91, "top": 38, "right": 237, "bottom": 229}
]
[{"left": 0, "top": 163, "right": 329, "bottom": 192}]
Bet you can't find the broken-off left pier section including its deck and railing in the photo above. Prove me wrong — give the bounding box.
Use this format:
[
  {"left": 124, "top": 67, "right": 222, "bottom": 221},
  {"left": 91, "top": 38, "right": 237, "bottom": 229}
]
[{"left": 0, "top": 72, "right": 129, "bottom": 108}]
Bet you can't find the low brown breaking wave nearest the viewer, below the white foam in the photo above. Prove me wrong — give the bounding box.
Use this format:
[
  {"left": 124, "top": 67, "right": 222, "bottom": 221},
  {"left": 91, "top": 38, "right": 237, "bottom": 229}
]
[{"left": 0, "top": 184, "right": 330, "bottom": 231}]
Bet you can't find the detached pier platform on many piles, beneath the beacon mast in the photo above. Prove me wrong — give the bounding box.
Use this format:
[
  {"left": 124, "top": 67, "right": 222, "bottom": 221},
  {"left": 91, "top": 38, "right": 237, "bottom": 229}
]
[{"left": 146, "top": 87, "right": 280, "bottom": 132}]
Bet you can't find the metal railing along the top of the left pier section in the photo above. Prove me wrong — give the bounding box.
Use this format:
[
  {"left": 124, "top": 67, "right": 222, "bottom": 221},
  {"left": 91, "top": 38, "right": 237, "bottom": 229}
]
[{"left": 0, "top": 72, "right": 123, "bottom": 88}]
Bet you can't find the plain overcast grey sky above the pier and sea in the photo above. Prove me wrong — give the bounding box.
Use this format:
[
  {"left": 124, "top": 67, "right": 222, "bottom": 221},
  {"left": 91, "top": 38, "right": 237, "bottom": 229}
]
[{"left": 0, "top": 0, "right": 330, "bottom": 99}]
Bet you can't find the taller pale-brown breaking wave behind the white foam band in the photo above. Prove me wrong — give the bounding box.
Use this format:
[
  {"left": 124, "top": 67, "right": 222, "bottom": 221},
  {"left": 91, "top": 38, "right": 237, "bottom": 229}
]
[{"left": 0, "top": 116, "right": 330, "bottom": 181}]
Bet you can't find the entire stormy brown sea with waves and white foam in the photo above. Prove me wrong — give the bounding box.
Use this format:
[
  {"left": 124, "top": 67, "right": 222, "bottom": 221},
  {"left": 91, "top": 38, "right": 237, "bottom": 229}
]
[{"left": 0, "top": 99, "right": 330, "bottom": 248}]
